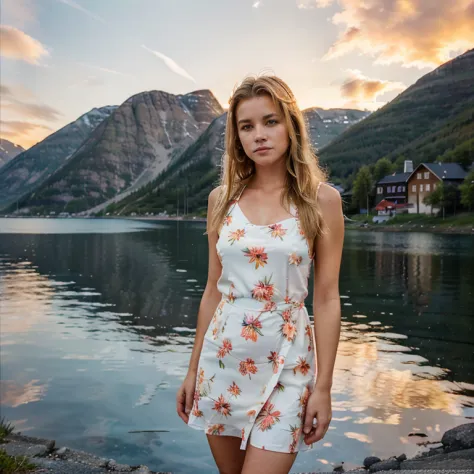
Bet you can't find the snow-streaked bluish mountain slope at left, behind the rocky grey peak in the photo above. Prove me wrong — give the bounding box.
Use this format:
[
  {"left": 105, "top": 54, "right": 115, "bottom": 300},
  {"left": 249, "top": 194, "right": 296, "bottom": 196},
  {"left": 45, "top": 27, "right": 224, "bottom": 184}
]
[{"left": 0, "top": 106, "right": 116, "bottom": 208}]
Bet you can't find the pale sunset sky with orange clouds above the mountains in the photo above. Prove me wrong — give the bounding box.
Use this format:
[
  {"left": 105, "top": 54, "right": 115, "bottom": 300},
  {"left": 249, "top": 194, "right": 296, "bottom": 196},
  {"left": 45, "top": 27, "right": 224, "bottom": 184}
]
[{"left": 0, "top": 0, "right": 474, "bottom": 148}]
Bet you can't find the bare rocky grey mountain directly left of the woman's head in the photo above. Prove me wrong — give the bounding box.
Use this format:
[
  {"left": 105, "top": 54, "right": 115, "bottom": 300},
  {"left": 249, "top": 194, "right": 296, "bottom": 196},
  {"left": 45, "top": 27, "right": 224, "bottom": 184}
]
[{"left": 12, "top": 90, "right": 223, "bottom": 212}]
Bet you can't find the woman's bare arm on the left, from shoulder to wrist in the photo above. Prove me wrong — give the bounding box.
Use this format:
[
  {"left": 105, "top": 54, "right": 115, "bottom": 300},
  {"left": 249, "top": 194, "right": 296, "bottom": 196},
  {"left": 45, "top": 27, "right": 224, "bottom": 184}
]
[{"left": 188, "top": 186, "right": 222, "bottom": 373}]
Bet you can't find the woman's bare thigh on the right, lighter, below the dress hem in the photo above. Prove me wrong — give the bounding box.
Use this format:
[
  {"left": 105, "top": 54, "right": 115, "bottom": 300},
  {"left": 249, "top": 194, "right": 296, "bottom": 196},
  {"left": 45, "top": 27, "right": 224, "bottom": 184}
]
[{"left": 242, "top": 444, "right": 297, "bottom": 474}]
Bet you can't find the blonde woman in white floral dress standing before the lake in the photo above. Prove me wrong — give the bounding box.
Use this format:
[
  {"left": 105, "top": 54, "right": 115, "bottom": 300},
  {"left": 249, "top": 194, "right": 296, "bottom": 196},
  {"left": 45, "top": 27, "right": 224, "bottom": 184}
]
[{"left": 176, "top": 76, "right": 344, "bottom": 474}]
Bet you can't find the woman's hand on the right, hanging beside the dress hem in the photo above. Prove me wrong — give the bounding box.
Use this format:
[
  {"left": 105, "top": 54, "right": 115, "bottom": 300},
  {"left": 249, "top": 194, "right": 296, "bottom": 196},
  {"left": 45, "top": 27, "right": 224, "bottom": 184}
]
[{"left": 303, "top": 387, "right": 332, "bottom": 445}]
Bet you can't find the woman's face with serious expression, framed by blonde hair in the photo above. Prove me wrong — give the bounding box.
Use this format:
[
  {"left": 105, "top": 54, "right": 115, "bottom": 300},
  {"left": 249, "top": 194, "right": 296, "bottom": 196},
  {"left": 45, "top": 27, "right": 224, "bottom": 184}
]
[{"left": 236, "top": 94, "right": 290, "bottom": 165}]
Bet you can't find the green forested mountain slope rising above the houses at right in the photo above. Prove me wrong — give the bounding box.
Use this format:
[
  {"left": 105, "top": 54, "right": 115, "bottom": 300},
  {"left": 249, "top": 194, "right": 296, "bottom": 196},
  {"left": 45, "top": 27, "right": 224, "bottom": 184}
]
[{"left": 320, "top": 50, "right": 474, "bottom": 178}]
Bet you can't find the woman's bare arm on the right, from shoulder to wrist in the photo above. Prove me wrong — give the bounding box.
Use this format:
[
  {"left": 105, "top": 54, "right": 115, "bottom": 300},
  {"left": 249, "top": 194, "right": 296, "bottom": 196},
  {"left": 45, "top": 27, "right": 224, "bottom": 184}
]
[{"left": 313, "top": 183, "right": 344, "bottom": 391}]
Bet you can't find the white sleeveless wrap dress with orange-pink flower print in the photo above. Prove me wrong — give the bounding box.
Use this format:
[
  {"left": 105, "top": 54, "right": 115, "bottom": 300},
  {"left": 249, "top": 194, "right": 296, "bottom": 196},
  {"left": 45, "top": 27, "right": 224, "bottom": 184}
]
[{"left": 188, "top": 181, "right": 316, "bottom": 453}]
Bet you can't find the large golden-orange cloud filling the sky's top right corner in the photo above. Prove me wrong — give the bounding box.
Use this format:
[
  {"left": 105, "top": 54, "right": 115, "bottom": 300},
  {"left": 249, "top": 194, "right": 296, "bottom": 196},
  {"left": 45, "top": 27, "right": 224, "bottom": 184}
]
[{"left": 314, "top": 0, "right": 474, "bottom": 68}]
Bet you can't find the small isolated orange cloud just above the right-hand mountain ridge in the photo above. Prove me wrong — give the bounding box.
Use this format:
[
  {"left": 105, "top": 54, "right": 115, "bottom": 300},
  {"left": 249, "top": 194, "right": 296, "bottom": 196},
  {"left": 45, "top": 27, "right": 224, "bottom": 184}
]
[{"left": 341, "top": 70, "right": 406, "bottom": 103}]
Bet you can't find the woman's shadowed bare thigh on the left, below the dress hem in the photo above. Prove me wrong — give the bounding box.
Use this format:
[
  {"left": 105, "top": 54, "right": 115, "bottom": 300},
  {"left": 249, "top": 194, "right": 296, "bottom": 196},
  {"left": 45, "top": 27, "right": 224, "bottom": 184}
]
[{"left": 206, "top": 435, "right": 245, "bottom": 474}]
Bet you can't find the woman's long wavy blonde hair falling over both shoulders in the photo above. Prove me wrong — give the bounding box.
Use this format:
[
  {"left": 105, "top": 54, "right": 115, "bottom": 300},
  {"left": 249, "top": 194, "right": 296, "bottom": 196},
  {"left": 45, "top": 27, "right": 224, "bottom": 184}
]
[{"left": 206, "top": 75, "right": 326, "bottom": 256}]
